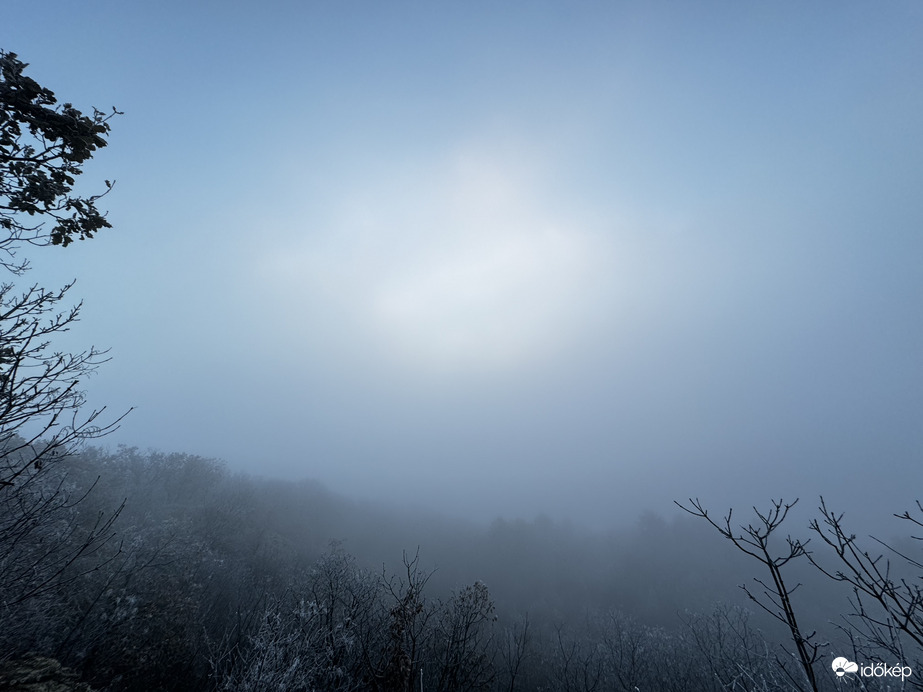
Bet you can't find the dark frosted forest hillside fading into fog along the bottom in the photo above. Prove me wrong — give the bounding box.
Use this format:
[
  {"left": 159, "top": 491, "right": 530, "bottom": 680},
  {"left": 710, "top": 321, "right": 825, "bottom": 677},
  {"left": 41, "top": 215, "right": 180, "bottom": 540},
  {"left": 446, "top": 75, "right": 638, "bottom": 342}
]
[{"left": 0, "top": 448, "right": 920, "bottom": 691}]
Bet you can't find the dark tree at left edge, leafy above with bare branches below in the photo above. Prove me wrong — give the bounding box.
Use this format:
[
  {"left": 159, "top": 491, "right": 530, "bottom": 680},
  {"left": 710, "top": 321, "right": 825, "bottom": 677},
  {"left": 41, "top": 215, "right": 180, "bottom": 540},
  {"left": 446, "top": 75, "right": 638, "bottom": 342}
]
[{"left": 0, "top": 51, "right": 118, "bottom": 627}]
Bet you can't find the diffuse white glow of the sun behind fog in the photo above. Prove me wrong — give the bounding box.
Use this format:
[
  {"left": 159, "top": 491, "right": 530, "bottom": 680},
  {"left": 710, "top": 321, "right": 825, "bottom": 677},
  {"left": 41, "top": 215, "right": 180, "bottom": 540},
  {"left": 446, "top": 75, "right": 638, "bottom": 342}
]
[{"left": 260, "top": 145, "right": 603, "bottom": 371}]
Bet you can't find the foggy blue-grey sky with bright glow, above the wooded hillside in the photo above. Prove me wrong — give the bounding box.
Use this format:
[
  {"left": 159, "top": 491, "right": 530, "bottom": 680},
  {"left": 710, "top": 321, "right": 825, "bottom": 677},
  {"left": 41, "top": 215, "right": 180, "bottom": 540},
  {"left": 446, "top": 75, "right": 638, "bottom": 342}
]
[{"left": 0, "top": 0, "right": 923, "bottom": 525}]
